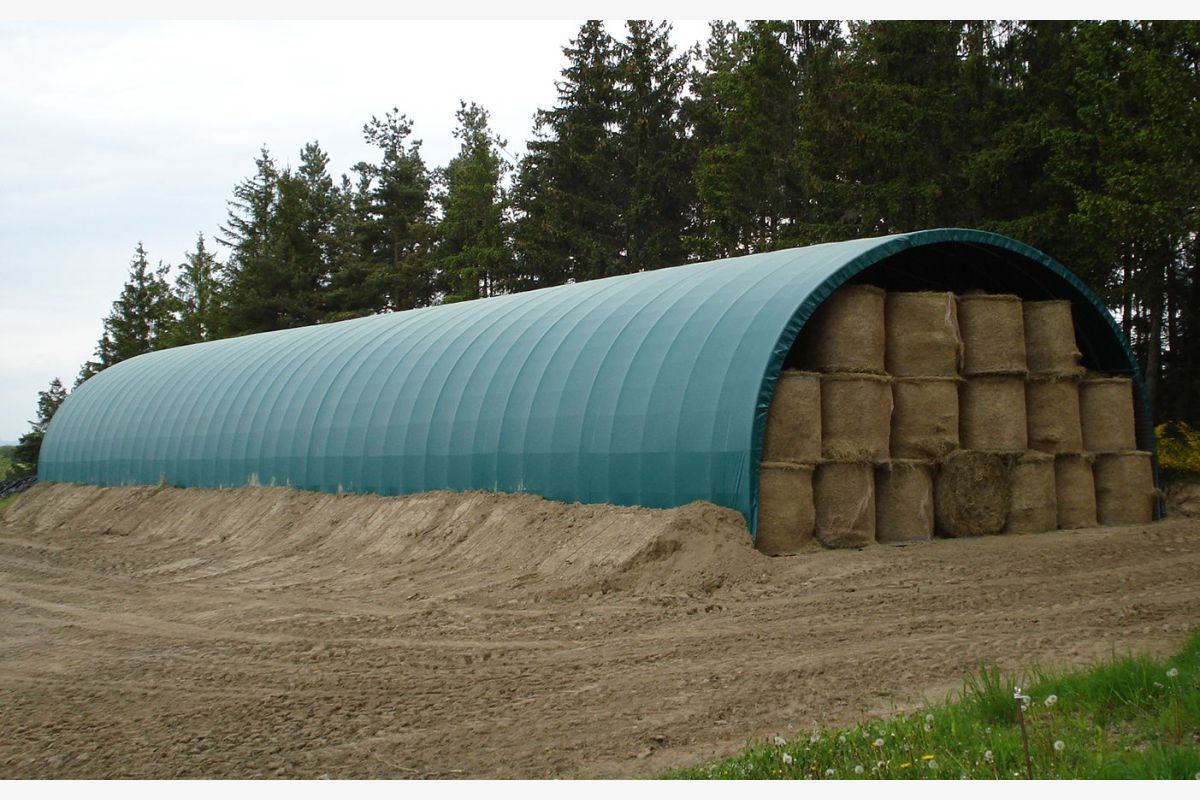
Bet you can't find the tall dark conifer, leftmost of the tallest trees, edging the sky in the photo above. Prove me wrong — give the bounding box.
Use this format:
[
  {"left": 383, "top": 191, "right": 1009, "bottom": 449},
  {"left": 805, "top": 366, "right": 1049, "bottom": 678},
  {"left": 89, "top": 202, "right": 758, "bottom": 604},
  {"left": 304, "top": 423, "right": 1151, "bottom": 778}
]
[{"left": 516, "top": 20, "right": 624, "bottom": 287}]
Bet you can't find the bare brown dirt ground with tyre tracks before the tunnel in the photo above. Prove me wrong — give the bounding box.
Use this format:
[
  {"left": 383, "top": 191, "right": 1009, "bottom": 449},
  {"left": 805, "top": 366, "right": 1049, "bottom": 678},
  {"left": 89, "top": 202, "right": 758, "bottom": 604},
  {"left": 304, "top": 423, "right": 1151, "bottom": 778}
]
[{"left": 0, "top": 485, "right": 1200, "bottom": 778}]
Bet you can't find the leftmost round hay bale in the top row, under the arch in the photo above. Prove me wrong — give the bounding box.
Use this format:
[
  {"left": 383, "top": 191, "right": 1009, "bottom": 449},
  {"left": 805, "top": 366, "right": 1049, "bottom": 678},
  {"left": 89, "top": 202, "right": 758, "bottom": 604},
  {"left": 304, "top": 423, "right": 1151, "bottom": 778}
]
[{"left": 797, "top": 284, "right": 884, "bottom": 374}]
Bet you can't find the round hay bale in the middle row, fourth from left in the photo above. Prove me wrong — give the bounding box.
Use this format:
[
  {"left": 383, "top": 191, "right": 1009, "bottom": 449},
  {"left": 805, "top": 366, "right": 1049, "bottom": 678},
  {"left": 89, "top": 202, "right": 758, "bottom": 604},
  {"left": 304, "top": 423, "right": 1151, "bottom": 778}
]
[{"left": 959, "top": 375, "right": 1028, "bottom": 452}]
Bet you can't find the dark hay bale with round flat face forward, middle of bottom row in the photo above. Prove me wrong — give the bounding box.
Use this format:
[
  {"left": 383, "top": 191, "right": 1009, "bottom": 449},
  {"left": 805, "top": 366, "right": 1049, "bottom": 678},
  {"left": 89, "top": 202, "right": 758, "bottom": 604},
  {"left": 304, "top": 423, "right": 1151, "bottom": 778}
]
[{"left": 934, "top": 450, "right": 1013, "bottom": 536}]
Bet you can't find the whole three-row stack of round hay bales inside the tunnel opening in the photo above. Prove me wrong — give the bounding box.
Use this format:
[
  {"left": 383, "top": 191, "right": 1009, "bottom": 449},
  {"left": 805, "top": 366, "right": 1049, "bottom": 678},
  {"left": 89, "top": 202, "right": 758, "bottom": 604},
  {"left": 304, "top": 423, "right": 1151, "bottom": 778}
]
[{"left": 758, "top": 284, "right": 1156, "bottom": 554}]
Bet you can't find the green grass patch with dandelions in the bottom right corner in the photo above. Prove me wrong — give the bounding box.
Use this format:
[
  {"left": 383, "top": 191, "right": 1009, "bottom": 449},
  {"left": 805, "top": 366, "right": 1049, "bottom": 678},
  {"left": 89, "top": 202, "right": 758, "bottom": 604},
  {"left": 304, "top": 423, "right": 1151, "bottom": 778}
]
[{"left": 666, "top": 631, "right": 1200, "bottom": 780}]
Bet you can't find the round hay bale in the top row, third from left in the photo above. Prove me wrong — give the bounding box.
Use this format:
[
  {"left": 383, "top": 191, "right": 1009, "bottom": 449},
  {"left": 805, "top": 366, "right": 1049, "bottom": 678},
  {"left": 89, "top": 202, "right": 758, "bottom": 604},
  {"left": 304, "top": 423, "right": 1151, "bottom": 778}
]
[{"left": 959, "top": 294, "right": 1028, "bottom": 375}]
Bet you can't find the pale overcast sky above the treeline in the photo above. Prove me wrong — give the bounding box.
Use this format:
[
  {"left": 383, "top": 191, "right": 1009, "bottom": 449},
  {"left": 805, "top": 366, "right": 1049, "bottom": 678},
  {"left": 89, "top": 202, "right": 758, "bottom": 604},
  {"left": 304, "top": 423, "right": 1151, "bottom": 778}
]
[{"left": 0, "top": 20, "right": 708, "bottom": 443}]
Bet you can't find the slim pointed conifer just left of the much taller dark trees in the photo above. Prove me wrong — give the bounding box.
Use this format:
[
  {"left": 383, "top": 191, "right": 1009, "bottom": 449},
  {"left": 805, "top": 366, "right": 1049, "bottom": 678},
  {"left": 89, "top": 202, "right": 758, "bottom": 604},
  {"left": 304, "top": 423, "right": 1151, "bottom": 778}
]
[{"left": 433, "top": 103, "right": 511, "bottom": 302}]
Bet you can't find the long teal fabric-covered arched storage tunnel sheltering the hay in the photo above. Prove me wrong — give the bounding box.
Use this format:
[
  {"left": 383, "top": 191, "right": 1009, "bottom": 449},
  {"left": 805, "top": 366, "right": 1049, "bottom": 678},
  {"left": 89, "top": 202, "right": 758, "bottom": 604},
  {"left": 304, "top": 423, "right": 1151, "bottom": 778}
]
[{"left": 38, "top": 229, "right": 1153, "bottom": 533}]
